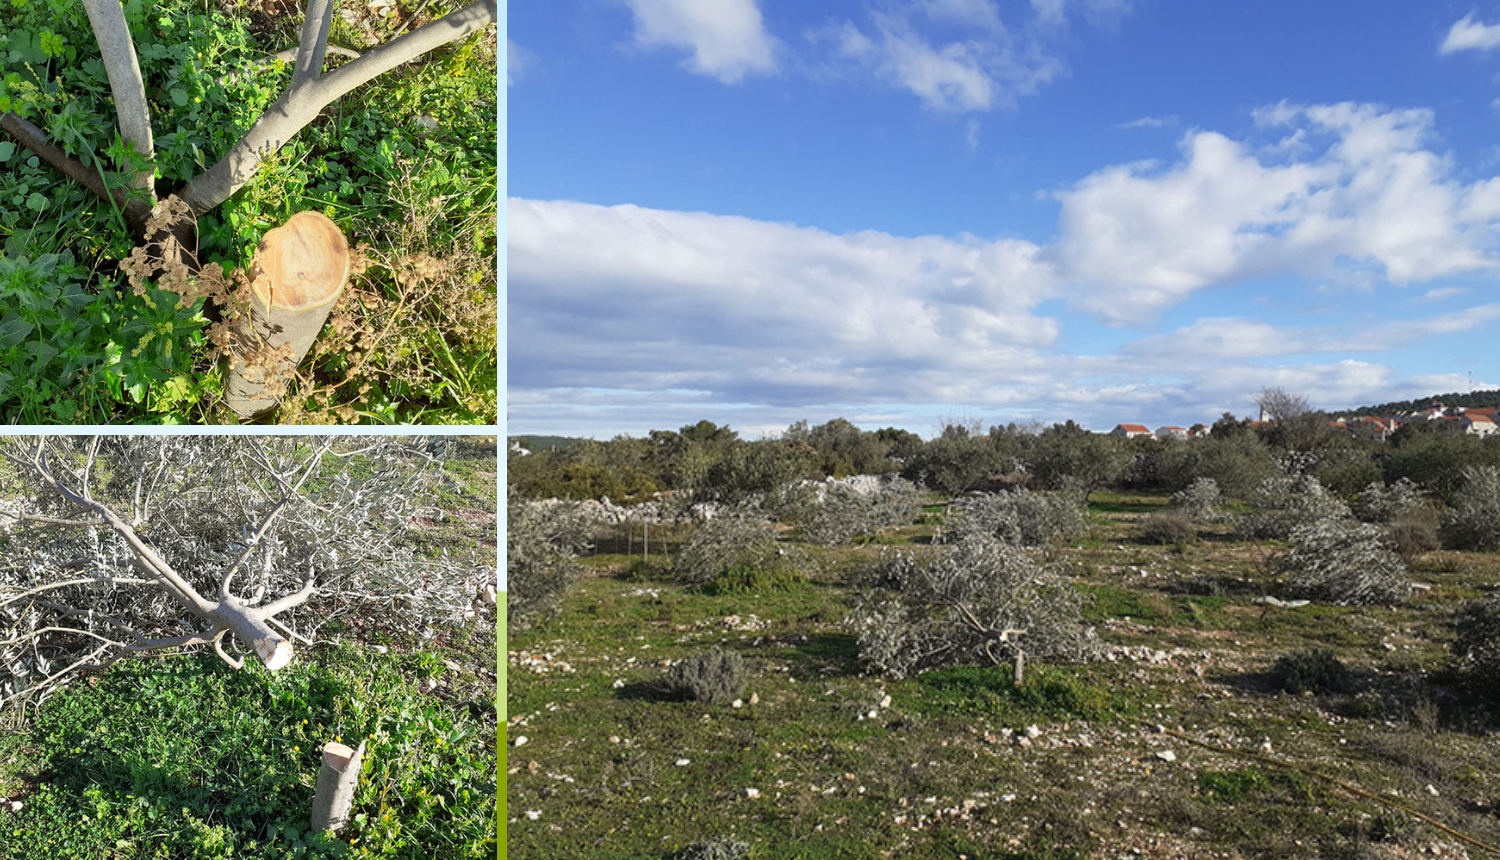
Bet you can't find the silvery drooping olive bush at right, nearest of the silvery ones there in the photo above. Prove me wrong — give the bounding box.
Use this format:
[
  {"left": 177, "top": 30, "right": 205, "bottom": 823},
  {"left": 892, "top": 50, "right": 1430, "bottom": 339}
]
[{"left": 1278, "top": 519, "right": 1412, "bottom": 606}]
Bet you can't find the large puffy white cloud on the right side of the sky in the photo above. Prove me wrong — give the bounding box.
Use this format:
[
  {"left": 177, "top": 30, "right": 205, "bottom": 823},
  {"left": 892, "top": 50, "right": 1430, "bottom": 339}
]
[{"left": 1056, "top": 104, "right": 1500, "bottom": 323}]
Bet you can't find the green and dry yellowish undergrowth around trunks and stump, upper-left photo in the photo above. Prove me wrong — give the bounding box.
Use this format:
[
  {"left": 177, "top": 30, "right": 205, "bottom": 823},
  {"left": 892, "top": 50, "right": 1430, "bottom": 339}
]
[{"left": 0, "top": 0, "right": 498, "bottom": 425}]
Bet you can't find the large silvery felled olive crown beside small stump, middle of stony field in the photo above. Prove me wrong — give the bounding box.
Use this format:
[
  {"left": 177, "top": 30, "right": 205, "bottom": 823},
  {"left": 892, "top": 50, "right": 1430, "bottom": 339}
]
[{"left": 846, "top": 533, "right": 1098, "bottom": 678}]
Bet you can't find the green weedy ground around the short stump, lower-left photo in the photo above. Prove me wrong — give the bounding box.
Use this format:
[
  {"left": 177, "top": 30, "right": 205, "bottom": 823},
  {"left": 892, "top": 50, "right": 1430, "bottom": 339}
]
[{"left": 0, "top": 440, "right": 498, "bottom": 860}]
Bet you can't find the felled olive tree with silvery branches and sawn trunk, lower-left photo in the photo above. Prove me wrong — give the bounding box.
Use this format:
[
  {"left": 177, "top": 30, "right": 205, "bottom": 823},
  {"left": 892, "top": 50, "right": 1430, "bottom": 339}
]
[{"left": 0, "top": 437, "right": 483, "bottom": 704}]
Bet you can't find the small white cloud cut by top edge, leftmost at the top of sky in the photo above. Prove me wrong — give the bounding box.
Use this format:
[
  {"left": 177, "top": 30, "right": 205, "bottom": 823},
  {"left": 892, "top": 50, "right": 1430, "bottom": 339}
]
[{"left": 626, "top": 0, "right": 777, "bottom": 84}]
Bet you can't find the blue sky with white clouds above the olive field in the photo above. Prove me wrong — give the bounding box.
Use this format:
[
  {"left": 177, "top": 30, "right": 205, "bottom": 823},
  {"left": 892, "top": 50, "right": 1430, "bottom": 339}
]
[{"left": 506, "top": 0, "right": 1500, "bottom": 438}]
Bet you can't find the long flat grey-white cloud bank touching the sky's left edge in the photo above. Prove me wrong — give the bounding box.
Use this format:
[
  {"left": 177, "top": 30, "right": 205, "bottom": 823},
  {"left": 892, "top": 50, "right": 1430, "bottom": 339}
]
[{"left": 507, "top": 200, "right": 1058, "bottom": 404}]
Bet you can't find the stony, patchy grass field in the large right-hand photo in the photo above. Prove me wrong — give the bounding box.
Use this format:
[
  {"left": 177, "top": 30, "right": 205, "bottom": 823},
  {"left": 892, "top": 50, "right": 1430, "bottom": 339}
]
[{"left": 507, "top": 492, "right": 1500, "bottom": 860}]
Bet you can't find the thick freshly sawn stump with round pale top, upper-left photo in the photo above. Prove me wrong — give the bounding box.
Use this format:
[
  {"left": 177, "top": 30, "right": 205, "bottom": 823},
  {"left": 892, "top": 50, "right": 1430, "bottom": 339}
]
[{"left": 225, "top": 212, "right": 350, "bottom": 419}]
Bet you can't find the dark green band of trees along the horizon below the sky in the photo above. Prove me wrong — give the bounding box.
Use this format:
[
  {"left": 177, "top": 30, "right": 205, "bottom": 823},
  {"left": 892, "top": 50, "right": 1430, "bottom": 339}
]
[{"left": 507, "top": 413, "right": 1500, "bottom": 503}]
